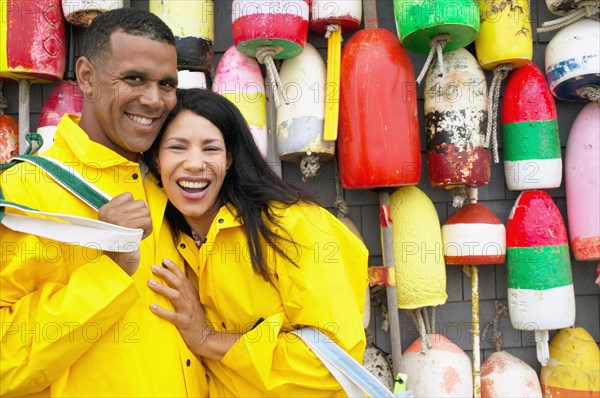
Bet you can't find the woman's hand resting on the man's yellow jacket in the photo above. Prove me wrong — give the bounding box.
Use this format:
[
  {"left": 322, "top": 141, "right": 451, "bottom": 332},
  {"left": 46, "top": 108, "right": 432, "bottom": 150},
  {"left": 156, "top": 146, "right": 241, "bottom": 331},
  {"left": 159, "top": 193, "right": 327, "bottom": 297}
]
[{"left": 148, "top": 259, "right": 239, "bottom": 360}]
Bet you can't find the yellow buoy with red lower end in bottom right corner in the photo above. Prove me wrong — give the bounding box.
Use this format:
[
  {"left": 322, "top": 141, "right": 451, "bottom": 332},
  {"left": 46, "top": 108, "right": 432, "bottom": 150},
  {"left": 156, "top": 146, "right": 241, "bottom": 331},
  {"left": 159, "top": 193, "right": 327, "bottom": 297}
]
[{"left": 540, "top": 327, "right": 600, "bottom": 398}]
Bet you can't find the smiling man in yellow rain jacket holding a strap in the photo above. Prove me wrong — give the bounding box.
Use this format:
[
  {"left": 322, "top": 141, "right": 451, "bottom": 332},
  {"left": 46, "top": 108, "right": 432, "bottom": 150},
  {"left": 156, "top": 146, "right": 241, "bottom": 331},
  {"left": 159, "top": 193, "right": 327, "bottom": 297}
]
[{"left": 0, "top": 9, "right": 207, "bottom": 397}]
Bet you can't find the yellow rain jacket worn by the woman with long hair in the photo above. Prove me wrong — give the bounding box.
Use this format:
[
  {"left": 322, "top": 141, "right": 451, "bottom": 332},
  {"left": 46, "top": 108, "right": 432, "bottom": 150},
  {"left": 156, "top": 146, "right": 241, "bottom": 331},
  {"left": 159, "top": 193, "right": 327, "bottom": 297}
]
[{"left": 178, "top": 205, "right": 368, "bottom": 397}]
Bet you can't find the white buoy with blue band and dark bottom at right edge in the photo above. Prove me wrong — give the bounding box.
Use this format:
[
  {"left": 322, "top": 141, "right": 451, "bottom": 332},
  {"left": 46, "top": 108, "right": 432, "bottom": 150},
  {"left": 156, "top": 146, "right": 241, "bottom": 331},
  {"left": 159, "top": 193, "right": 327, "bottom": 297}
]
[{"left": 545, "top": 19, "right": 600, "bottom": 101}]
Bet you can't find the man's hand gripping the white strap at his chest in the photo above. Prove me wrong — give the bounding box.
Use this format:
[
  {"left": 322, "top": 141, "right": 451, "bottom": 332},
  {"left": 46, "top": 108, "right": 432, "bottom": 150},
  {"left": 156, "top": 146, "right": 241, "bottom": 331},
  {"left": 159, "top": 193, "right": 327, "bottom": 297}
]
[{"left": 98, "top": 192, "right": 152, "bottom": 275}]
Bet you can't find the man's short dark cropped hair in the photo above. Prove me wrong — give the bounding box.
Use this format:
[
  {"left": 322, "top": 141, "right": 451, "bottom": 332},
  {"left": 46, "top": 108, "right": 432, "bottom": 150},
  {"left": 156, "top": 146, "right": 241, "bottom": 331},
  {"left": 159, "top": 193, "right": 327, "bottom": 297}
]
[{"left": 81, "top": 8, "right": 175, "bottom": 62}]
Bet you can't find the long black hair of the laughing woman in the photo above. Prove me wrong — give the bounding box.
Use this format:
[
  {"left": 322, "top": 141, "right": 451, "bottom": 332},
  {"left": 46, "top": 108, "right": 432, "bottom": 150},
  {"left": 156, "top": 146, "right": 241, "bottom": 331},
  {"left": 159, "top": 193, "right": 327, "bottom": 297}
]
[{"left": 144, "top": 89, "right": 317, "bottom": 281}]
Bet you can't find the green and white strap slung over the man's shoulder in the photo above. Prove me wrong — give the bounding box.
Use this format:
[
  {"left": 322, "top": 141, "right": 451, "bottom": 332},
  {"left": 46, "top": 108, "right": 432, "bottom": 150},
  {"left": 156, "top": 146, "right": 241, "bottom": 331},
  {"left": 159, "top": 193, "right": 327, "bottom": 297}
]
[{"left": 0, "top": 155, "right": 144, "bottom": 252}]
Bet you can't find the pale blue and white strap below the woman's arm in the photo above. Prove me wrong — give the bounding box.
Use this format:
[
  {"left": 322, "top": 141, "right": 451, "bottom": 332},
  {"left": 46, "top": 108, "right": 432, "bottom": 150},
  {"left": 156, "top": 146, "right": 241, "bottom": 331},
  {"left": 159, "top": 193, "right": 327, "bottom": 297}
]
[{"left": 291, "top": 327, "right": 396, "bottom": 398}]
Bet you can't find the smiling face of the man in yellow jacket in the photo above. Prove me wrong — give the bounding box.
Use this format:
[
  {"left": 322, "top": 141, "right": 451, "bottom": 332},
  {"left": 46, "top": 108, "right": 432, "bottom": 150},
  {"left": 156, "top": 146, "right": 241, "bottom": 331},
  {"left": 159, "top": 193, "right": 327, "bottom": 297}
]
[{"left": 77, "top": 32, "right": 177, "bottom": 161}]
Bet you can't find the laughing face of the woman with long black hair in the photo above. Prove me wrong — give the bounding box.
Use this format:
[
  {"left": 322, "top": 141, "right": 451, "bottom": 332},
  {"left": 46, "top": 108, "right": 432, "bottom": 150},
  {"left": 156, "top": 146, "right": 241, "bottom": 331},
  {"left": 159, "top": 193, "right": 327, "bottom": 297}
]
[{"left": 157, "top": 110, "right": 231, "bottom": 234}]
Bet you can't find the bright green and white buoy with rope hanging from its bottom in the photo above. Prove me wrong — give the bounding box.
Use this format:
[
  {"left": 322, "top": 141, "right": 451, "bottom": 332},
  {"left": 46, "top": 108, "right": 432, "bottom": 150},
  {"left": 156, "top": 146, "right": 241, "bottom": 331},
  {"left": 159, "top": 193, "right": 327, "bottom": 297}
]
[{"left": 394, "top": 0, "right": 479, "bottom": 84}]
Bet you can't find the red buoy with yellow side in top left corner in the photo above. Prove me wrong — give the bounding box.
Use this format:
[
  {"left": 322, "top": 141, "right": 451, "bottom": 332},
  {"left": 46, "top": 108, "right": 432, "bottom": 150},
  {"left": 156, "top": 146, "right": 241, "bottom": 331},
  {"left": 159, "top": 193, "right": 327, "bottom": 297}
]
[{"left": 0, "top": 0, "right": 66, "bottom": 83}]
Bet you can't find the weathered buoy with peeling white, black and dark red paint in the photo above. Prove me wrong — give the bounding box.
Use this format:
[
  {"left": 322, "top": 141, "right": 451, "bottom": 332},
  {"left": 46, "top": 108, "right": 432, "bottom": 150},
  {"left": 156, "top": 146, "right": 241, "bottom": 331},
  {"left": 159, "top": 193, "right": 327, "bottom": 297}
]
[{"left": 424, "top": 49, "right": 491, "bottom": 204}]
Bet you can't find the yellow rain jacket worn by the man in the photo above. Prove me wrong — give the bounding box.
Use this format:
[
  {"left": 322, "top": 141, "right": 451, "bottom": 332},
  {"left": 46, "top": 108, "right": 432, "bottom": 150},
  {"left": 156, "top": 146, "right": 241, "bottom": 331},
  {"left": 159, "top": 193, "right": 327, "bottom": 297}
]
[{"left": 0, "top": 116, "right": 208, "bottom": 397}]
